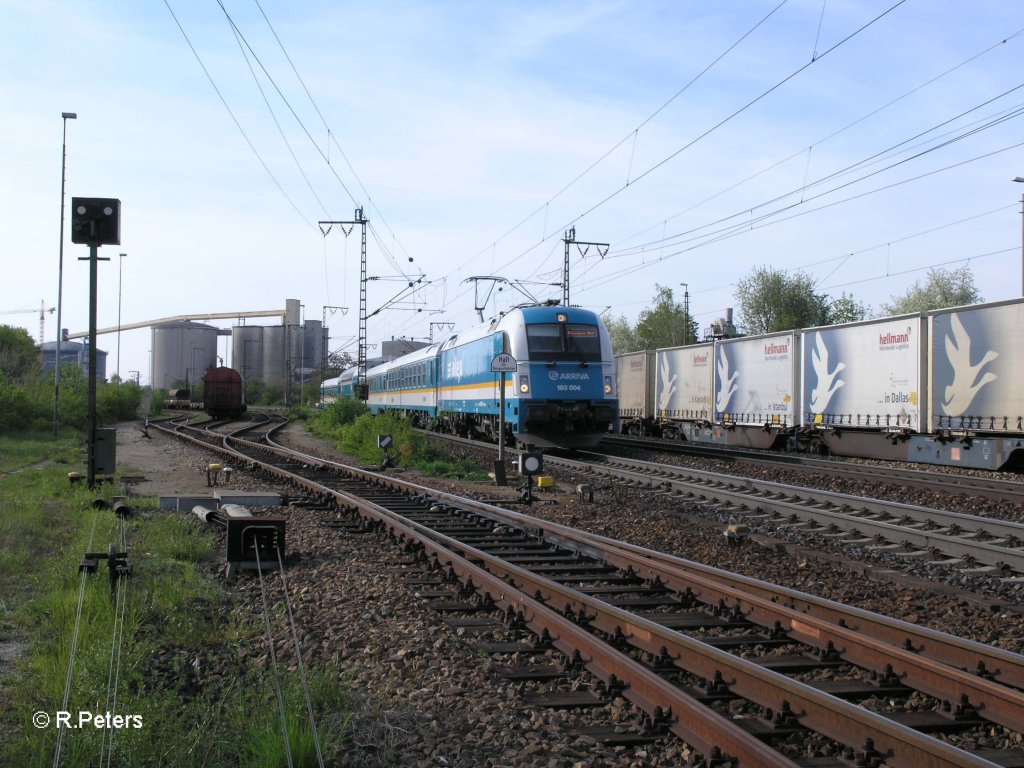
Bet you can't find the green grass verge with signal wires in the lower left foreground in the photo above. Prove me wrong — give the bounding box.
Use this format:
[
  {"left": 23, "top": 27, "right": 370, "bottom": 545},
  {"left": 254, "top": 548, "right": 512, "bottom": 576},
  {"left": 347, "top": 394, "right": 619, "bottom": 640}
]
[{"left": 0, "top": 438, "right": 376, "bottom": 767}]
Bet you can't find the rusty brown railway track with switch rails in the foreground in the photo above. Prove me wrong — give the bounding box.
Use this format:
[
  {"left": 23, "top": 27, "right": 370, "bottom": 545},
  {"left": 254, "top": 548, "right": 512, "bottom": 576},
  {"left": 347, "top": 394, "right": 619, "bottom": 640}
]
[{"left": 149, "top": 425, "right": 1024, "bottom": 766}]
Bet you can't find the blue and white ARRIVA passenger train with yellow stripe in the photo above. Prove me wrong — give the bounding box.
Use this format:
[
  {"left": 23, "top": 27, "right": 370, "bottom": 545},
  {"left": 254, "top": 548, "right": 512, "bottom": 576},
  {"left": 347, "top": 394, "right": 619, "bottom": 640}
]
[{"left": 321, "top": 303, "right": 618, "bottom": 447}]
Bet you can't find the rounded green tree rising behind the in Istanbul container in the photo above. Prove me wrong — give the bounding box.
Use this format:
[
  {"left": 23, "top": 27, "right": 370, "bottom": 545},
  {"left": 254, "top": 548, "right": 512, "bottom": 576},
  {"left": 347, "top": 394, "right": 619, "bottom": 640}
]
[{"left": 736, "top": 266, "right": 830, "bottom": 335}]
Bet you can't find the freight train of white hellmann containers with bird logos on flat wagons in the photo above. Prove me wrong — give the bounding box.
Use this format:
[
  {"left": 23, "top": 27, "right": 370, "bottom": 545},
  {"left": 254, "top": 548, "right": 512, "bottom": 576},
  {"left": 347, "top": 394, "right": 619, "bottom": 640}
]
[{"left": 615, "top": 299, "right": 1024, "bottom": 470}]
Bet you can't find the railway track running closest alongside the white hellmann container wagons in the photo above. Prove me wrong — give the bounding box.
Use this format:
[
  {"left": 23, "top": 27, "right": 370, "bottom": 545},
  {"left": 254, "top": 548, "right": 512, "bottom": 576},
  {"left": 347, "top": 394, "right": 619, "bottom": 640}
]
[{"left": 601, "top": 435, "right": 1024, "bottom": 505}]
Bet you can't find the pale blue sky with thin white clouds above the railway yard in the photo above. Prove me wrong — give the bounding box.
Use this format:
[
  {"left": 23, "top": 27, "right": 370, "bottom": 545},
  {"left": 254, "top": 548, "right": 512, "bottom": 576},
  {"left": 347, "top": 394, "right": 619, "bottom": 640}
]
[{"left": 0, "top": 0, "right": 1024, "bottom": 382}]
